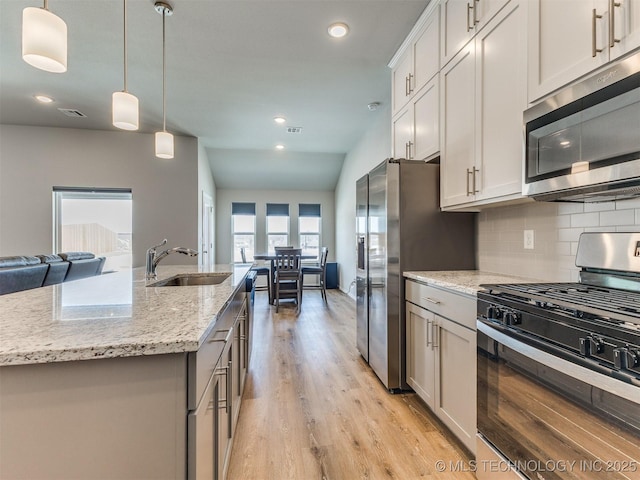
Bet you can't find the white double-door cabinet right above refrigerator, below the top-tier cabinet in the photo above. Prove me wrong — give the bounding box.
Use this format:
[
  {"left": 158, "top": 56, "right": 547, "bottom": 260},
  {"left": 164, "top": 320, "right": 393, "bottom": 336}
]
[{"left": 392, "top": 76, "right": 440, "bottom": 160}]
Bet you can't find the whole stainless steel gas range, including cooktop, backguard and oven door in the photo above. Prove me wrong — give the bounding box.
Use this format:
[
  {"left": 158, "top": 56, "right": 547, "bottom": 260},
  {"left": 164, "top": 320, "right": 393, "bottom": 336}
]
[{"left": 476, "top": 233, "right": 640, "bottom": 480}]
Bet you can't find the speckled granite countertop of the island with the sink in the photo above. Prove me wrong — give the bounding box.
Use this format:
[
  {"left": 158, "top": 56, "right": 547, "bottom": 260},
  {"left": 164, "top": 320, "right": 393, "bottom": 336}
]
[{"left": 0, "top": 265, "right": 250, "bottom": 366}]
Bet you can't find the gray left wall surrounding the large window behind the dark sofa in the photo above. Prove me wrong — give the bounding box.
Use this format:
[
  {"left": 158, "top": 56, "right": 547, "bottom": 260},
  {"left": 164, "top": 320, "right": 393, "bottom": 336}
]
[{"left": 0, "top": 125, "right": 200, "bottom": 266}]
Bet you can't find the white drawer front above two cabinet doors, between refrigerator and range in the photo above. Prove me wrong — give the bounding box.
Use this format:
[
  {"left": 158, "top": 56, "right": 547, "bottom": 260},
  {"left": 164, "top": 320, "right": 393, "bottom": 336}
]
[{"left": 405, "top": 280, "right": 476, "bottom": 331}]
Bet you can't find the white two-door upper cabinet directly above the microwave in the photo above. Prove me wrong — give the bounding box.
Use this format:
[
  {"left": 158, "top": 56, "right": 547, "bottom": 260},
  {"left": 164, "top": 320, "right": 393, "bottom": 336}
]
[{"left": 527, "top": 0, "right": 640, "bottom": 102}]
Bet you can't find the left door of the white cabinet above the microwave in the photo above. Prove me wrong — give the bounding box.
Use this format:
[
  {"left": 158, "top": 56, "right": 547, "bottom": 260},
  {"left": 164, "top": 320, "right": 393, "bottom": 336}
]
[{"left": 525, "top": 0, "right": 609, "bottom": 102}]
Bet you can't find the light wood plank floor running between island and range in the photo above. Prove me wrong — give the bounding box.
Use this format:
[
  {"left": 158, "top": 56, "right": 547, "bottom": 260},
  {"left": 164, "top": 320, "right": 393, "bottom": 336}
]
[{"left": 227, "top": 290, "right": 475, "bottom": 480}]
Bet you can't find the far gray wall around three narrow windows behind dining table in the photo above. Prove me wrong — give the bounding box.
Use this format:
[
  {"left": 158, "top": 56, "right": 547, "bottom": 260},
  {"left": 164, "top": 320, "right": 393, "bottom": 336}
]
[{"left": 216, "top": 188, "right": 340, "bottom": 268}]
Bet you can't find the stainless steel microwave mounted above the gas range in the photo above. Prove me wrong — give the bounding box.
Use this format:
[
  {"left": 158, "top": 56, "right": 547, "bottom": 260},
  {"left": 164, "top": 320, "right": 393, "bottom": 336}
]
[{"left": 523, "top": 52, "right": 640, "bottom": 202}]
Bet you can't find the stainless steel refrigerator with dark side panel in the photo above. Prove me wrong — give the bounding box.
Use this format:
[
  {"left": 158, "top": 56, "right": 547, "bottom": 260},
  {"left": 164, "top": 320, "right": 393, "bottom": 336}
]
[{"left": 356, "top": 159, "right": 476, "bottom": 392}]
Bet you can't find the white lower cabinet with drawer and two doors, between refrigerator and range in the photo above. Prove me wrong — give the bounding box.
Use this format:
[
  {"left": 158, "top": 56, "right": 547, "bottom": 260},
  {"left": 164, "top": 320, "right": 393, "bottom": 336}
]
[{"left": 406, "top": 280, "right": 476, "bottom": 453}]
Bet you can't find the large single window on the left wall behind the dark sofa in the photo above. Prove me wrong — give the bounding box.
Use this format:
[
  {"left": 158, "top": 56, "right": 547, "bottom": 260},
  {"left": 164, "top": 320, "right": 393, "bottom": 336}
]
[{"left": 53, "top": 187, "right": 133, "bottom": 272}]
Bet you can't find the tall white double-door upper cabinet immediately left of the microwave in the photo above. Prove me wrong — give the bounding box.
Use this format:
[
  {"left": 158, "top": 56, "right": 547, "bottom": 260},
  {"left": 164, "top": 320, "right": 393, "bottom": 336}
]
[{"left": 440, "top": 1, "right": 527, "bottom": 209}]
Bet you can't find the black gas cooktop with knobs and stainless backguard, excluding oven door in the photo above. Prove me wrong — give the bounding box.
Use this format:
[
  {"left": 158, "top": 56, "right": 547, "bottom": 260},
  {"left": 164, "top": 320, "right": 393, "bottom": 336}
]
[{"left": 478, "top": 233, "right": 640, "bottom": 385}]
